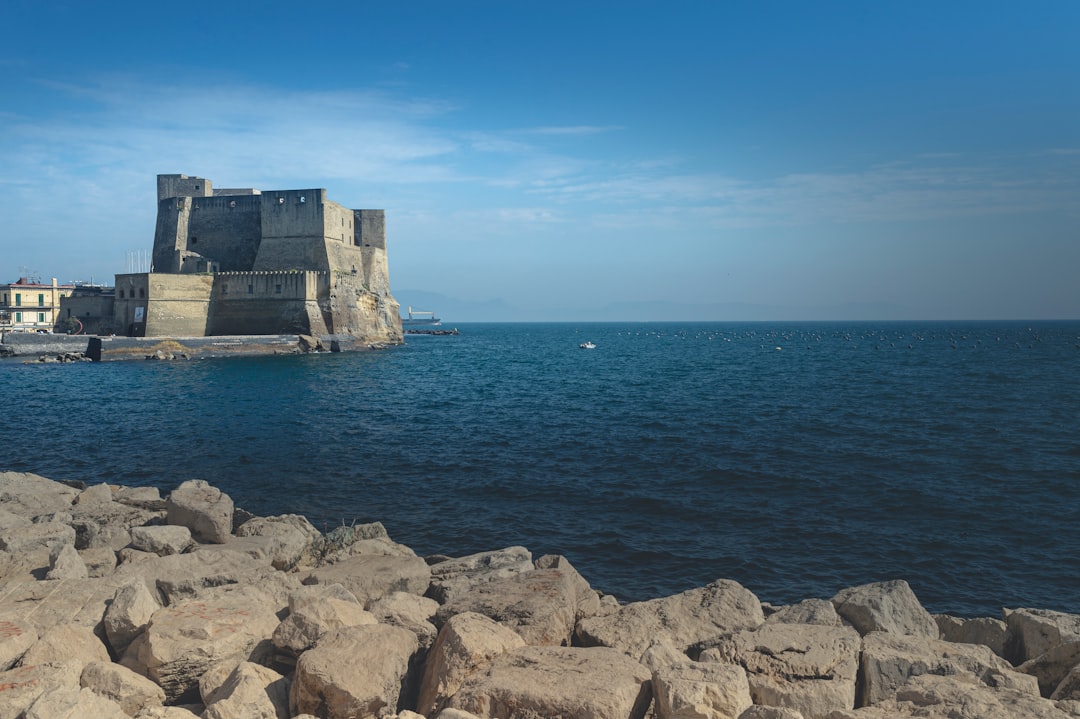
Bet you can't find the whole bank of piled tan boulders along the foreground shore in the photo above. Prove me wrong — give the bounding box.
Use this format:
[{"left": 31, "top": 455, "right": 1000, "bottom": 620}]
[{"left": 0, "top": 473, "right": 1080, "bottom": 719}]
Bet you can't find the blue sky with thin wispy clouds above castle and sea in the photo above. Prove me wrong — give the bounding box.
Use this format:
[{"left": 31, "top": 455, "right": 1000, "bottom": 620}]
[{"left": 0, "top": 0, "right": 1080, "bottom": 322}]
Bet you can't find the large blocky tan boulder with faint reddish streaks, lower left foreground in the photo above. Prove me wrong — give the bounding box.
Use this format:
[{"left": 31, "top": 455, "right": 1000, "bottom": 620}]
[{"left": 122, "top": 586, "right": 279, "bottom": 703}]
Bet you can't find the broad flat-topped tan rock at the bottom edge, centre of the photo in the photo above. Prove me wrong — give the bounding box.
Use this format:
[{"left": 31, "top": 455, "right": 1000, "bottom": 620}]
[{"left": 449, "top": 647, "right": 652, "bottom": 719}]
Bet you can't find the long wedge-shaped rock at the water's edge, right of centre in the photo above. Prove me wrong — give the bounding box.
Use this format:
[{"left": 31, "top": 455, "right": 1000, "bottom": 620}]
[{"left": 576, "top": 580, "right": 765, "bottom": 660}]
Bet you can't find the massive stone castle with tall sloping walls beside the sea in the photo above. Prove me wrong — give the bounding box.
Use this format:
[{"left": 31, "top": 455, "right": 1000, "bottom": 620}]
[{"left": 59, "top": 175, "right": 402, "bottom": 343}]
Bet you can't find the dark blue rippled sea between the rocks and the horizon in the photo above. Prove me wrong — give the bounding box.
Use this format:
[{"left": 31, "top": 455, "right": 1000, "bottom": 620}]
[{"left": 0, "top": 323, "right": 1080, "bottom": 615}]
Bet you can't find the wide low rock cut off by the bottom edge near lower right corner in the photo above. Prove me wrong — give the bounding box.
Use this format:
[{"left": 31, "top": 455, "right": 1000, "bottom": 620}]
[{"left": 828, "top": 675, "right": 1072, "bottom": 719}]
